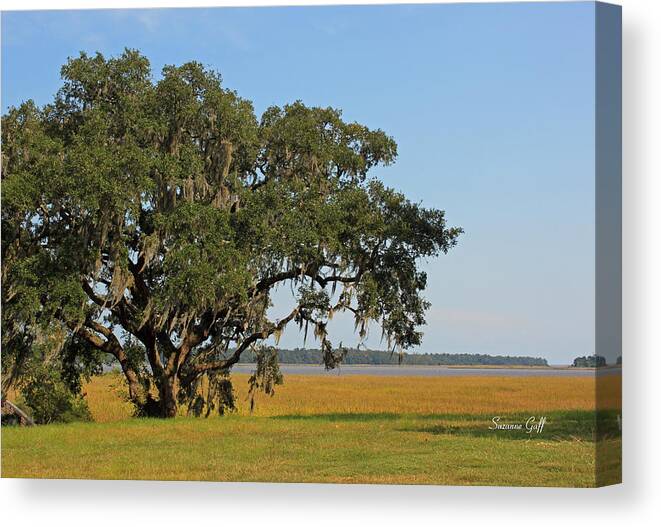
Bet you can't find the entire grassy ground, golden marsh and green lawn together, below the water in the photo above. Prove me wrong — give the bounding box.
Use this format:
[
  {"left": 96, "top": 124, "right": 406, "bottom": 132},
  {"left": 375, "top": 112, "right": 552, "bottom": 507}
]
[{"left": 2, "top": 374, "right": 621, "bottom": 487}]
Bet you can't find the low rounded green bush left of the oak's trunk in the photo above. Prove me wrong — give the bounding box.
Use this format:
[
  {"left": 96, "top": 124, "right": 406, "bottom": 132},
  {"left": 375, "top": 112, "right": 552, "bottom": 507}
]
[{"left": 21, "top": 365, "right": 92, "bottom": 424}]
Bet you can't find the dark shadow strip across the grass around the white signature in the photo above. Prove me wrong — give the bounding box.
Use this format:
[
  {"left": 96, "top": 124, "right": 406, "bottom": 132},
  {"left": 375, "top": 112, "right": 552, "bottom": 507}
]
[{"left": 272, "top": 410, "right": 621, "bottom": 441}]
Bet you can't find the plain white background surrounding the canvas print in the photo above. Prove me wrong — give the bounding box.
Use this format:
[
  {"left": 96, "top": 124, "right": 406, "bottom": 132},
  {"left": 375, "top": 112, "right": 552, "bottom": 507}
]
[{"left": 0, "top": 0, "right": 661, "bottom": 527}]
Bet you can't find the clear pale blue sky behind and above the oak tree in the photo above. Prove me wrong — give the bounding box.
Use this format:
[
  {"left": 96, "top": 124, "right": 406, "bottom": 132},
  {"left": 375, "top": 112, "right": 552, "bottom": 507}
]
[{"left": 2, "top": 2, "right": 595, "bottom": 364}]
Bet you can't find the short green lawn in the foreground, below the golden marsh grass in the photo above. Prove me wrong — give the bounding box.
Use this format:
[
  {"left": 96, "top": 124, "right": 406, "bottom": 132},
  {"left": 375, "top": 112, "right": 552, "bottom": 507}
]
[{"left": 2, "top": 412, "right": 620, "bottom": 486}]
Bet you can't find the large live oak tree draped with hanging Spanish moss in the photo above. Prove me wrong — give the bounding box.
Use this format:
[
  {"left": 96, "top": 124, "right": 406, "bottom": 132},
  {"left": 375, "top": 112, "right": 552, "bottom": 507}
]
[{"left": 2, "top": 50, "right": 461, "bottom": 417}]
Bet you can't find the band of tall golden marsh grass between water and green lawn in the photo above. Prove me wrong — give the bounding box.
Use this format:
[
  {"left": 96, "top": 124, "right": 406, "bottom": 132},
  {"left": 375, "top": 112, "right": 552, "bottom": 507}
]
[{"left": 84, "top": 374, "right": 622, "bottom": 422}]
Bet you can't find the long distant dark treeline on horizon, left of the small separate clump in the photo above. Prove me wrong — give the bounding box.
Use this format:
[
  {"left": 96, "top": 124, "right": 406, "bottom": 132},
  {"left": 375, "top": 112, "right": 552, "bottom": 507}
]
[{"left": 241, "top": 348, "right": 548, "bottom": 366}]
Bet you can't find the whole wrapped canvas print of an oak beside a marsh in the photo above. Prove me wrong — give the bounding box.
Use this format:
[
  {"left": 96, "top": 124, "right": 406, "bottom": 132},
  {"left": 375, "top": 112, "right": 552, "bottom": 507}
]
[{"left": 1, "top": 2, "right": 622, "bottom": 487}]
